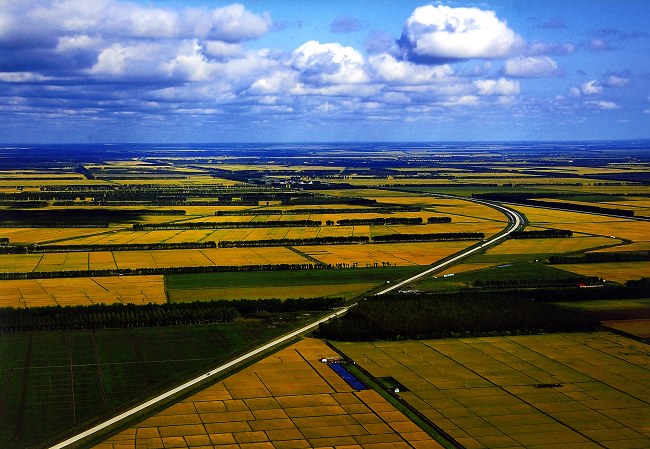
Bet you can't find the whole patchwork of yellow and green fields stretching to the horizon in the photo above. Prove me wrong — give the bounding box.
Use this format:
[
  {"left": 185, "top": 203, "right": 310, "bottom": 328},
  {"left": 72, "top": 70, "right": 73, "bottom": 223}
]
[{"left": 0, "top": 146, "right": 650, "bottom": 449}]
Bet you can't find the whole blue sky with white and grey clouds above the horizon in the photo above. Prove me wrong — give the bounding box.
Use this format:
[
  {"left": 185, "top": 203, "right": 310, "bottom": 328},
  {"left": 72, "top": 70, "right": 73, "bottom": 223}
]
[{"left": 0, "top": 0, "right": 650, "bottom": 143}]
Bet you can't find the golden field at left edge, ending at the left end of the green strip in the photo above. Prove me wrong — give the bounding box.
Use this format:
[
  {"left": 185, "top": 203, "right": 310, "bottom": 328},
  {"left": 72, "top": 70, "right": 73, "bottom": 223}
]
[{"left": 0, "top": 276, "right": 167, "bottom": 307}]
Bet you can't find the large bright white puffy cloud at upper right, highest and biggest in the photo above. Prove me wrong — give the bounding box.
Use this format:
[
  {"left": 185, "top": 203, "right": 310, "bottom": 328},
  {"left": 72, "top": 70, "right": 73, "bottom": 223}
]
[{"left": 401, "top": 5, "right": 523, "bottom": 62}]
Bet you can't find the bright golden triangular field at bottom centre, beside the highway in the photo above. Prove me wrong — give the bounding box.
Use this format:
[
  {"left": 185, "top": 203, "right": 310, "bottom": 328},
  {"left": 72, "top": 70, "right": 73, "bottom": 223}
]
[{"left": 94, "top": 339, "right": 442, "bottom": 449}]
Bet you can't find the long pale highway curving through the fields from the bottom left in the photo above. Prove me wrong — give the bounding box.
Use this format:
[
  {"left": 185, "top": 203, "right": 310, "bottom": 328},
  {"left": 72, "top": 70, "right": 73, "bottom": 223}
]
[{"left": 51, "top": 195, "right": 526, "bottom": 449}]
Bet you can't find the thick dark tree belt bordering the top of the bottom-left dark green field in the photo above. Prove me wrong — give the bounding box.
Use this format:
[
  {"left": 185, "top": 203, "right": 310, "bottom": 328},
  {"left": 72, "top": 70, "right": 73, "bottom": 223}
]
[{"left": 0, "top": 298, "right": 344, "bottom": 332}]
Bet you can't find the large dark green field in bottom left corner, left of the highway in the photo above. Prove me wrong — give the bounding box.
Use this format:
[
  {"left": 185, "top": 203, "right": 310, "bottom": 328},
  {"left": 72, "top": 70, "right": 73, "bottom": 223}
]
[{"left": 0, "top": 323, "right": 282, "bottom": 449}]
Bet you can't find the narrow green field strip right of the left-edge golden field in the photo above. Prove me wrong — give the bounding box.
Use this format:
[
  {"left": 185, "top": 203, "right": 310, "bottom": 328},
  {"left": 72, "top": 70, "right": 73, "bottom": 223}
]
[{"left": 166, "top": 267, "right": 419, "bottom": 290}]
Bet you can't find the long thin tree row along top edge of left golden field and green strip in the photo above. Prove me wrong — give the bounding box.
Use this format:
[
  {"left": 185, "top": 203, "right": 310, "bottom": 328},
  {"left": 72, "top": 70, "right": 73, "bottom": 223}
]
[{"left": 0, "top": 263, "right": 330, "bottom": 280}]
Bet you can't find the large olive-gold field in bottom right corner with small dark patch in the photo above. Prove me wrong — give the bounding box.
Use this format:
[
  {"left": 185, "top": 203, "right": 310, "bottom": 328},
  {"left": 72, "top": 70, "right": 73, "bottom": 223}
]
[{"left": 335, "top": 332, "right": 650, "bottom": 449}]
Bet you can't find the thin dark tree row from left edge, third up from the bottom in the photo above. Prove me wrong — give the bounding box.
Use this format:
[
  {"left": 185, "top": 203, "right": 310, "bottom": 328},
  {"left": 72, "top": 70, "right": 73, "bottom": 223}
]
[{"left": 0, "top": 241, "right": 217, "bottom": 254}]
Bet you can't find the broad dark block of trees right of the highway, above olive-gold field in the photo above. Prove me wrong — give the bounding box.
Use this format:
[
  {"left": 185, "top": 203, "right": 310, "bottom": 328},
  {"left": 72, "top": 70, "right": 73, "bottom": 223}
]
[{"left": 317, "top": 278, "right": 650, "bottom": 341}]
